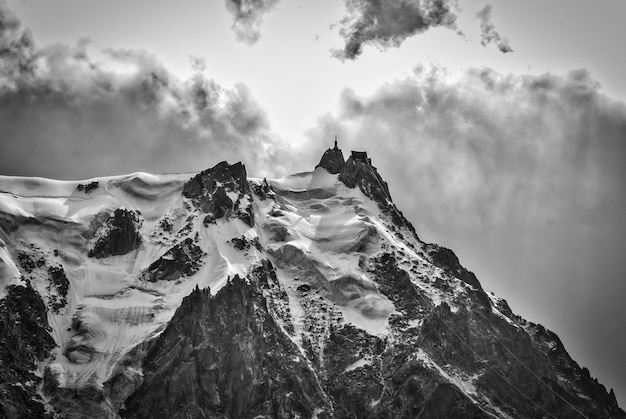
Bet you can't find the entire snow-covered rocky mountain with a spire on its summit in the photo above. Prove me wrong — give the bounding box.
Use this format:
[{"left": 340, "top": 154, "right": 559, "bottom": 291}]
[{"left": 0, "top": 145, "right": 626, "bottom": 419}]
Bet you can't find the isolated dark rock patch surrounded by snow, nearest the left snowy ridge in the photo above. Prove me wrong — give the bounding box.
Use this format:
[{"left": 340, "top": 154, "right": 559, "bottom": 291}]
[{"left": 88, "top": 208, "right": 141, "bottom": 259}]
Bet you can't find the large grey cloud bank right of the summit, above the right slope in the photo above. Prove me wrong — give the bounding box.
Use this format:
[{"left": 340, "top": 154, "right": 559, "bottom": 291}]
[{"left": 309, "top": 65, "right": 626, "bottom": 404}]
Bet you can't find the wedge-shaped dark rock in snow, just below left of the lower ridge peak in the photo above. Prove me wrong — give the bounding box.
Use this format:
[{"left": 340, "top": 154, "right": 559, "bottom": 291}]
[{"left": 140, "top": 237, "right": 204, "bottom": 282}]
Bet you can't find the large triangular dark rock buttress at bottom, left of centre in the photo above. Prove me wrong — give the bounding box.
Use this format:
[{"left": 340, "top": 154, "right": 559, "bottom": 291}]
[{"left": 122, "top": 264, "right": 328, "bottom": 418}]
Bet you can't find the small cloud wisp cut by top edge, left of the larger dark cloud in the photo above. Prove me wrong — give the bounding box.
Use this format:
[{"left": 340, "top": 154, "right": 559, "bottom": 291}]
[{"left": 225, "top": 0, "right": 278, "bottom": 44}]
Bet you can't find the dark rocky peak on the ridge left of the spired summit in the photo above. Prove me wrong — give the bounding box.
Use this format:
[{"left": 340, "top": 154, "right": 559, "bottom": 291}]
[{"left": 183, "top": 161, "right": 253, "bottom": 226}]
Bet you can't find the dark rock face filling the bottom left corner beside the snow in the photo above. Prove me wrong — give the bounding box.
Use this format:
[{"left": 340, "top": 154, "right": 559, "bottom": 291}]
[{"left": 0, "top": 284, "right": 55, "bottom": 418}]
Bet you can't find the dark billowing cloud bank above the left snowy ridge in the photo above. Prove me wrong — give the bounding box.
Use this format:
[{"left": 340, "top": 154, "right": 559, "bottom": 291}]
[{"left": 0, "top": 0, "right": 285, "bottom": 178}]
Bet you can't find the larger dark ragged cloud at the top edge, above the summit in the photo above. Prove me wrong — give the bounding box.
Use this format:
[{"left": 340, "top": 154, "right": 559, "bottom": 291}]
[{"left": 333, "top": 0, "right": 457, "bottom": 60}]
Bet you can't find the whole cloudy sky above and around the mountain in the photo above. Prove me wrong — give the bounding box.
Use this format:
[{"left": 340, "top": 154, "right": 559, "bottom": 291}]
[{"left": 0, "top": 0, "right": 626, "bottom": 407}]
